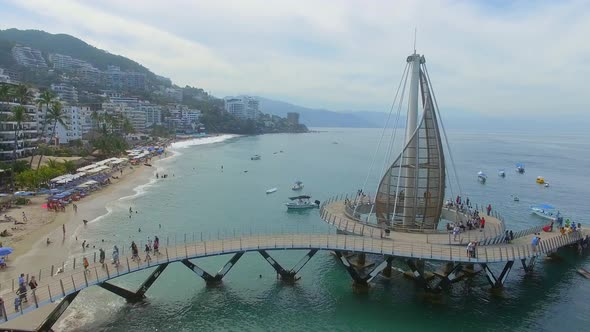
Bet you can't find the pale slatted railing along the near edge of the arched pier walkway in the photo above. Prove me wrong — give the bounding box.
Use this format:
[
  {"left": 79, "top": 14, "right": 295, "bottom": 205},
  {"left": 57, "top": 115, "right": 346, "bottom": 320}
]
[{"left": 3, "top": 232, "right": 583, "bottom": 319}]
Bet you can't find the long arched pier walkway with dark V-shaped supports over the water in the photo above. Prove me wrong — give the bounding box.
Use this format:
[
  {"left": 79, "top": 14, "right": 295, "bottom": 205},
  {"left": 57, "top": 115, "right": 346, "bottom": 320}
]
[{"left": 0, "top": 228, "right": 586, "bottom": 331}]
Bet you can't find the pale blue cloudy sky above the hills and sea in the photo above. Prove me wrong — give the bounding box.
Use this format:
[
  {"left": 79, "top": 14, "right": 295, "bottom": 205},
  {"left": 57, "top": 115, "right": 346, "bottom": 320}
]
[{"left": 0, "top": 0, "right": 590, "bottom": 119}]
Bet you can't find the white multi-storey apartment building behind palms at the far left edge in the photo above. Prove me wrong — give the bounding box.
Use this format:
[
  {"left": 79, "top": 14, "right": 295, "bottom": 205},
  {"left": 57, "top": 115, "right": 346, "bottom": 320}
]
[{"left": 0, "top": 103, "right": 39, "bottom": 160}]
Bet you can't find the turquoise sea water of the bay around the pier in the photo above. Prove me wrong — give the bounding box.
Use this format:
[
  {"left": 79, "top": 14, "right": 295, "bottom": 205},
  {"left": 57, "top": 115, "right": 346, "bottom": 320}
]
[{"left": 59, "top": 129, "right": 590, "bottom": 331}]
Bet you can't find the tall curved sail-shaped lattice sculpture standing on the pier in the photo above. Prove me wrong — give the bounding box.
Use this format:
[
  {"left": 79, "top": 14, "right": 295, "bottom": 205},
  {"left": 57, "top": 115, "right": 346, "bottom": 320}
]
[{"left": 375, "top": 54, "right": 445, "bottom": 231}]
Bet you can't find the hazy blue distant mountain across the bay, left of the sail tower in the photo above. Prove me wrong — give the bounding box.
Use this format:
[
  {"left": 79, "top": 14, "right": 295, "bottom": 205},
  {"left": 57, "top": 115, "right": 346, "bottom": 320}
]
[{"left": 256, "top": 97, "right": 405, "bottom": 128}]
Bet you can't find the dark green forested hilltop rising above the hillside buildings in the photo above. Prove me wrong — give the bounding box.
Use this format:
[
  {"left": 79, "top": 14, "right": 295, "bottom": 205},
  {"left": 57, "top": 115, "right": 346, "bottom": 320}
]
[{"left": 0, "top": 29, "right": 155, "bottom": 77}]
